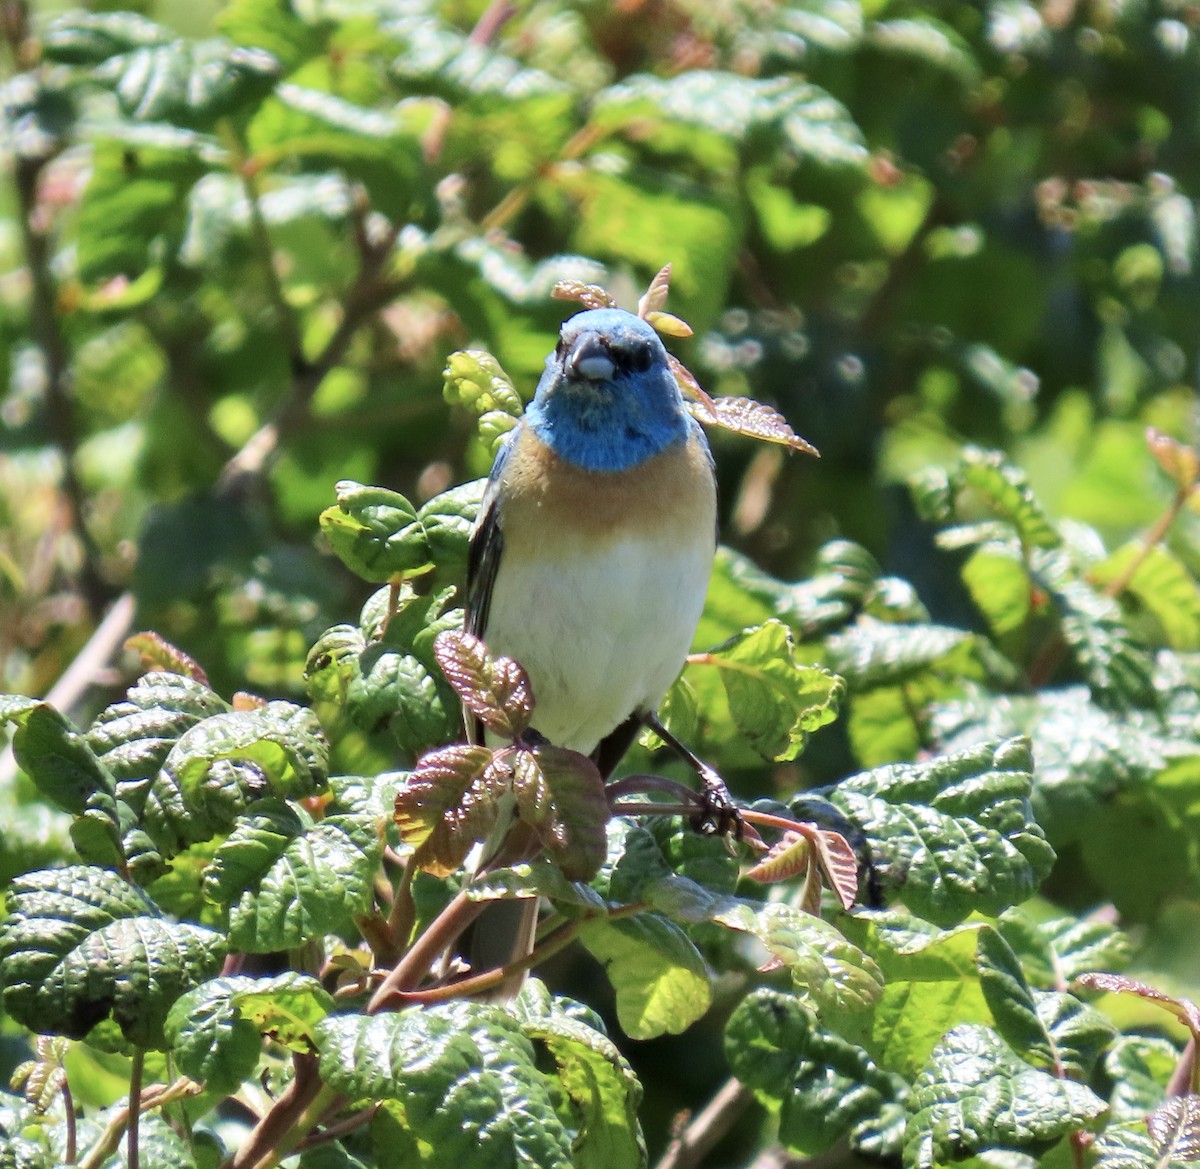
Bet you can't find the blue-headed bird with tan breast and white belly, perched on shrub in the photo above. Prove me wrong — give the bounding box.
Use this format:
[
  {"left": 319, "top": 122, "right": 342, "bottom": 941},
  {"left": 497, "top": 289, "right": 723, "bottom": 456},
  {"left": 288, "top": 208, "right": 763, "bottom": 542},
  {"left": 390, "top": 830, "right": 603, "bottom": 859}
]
[{"left": 466, "top": 307, "right": 716, "bottom": 997}]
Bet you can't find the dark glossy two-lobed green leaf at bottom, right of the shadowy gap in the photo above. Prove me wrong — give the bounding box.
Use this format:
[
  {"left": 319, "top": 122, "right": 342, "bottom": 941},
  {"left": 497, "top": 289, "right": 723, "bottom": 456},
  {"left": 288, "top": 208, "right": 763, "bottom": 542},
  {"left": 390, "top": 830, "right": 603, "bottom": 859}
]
[{"left": 725, "top": 989, "right": 907, "bottom": 1157}]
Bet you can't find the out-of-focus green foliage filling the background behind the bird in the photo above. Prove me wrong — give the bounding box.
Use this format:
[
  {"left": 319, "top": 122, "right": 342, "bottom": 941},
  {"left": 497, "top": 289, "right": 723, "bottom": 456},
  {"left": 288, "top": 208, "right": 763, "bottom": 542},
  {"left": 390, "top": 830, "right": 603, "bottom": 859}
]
[{"left": 0, "top": 0, "right": 1200, "bottom": 1152}]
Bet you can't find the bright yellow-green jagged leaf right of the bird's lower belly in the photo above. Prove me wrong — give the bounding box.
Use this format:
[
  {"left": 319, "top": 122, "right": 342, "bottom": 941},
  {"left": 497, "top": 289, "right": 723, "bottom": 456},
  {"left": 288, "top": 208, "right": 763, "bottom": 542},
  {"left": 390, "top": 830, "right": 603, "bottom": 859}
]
[{"left": 702, "top": 621, "right": 845, "bottom": 760}]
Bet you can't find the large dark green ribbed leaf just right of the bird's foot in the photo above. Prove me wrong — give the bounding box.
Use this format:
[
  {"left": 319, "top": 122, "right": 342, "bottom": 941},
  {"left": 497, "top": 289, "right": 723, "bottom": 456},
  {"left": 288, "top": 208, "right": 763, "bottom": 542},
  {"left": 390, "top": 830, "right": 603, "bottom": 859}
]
[{"left": 828, "top": 739, "right": 1054, "bottom": 925}]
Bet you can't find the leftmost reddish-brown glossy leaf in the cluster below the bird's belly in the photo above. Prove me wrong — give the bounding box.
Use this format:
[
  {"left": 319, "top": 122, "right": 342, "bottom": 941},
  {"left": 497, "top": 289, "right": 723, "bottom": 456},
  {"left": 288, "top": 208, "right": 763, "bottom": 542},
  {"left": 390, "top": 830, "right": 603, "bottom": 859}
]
[{"left": 396, "top": 745, "right": 499, "bottom": 876}]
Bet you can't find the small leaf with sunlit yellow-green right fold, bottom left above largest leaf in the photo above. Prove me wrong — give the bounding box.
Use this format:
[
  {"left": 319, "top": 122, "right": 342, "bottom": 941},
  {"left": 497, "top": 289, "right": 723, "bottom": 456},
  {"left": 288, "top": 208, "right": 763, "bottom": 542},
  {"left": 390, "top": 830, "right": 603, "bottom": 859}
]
[{"left": 166, "top": 971, "right": 334, "bottom": 1095}]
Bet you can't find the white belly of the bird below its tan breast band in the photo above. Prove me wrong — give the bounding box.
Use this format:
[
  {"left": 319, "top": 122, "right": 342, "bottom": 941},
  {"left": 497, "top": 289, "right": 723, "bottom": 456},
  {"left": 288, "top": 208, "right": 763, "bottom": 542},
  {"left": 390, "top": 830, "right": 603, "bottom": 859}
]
[{"left": 485, "top": 529, "right": 713, "bottom": 754}]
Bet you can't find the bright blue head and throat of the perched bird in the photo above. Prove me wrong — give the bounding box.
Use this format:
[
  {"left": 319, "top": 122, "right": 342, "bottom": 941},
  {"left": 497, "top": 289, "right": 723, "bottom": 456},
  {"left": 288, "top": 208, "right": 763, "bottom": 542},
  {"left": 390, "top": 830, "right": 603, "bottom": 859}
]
[{"left": 526, "top": 308, "right": 691, "bottom": 470}]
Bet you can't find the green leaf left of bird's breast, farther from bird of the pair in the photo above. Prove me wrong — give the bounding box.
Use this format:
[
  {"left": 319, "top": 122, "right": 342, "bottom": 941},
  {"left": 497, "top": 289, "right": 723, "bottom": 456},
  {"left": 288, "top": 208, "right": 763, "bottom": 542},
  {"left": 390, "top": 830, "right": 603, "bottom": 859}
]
[{"left": 320, "top": 479, "right": 433, "bottom": 585}]
